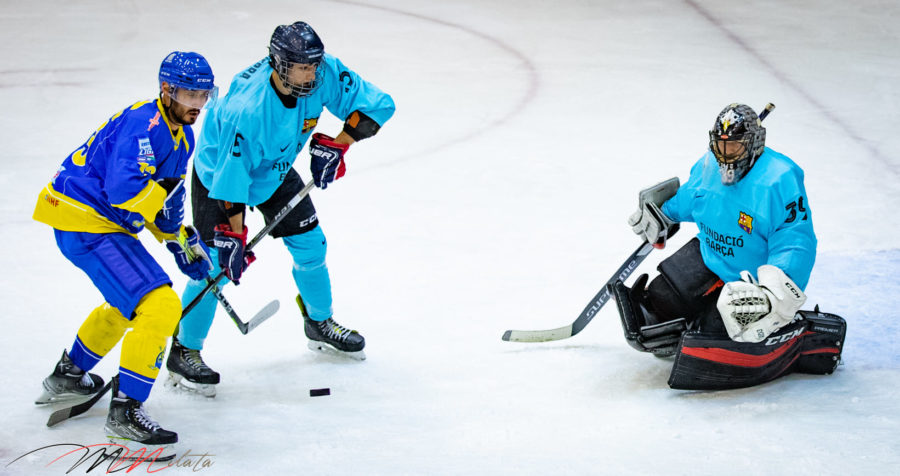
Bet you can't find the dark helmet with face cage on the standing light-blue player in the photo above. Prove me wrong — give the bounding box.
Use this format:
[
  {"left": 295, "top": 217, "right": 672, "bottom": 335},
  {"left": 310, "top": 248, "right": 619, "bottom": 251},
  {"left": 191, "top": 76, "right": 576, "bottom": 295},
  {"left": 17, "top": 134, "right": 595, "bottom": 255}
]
[{"left": 269, "top": 21, "right": 325, "bottom": 97}]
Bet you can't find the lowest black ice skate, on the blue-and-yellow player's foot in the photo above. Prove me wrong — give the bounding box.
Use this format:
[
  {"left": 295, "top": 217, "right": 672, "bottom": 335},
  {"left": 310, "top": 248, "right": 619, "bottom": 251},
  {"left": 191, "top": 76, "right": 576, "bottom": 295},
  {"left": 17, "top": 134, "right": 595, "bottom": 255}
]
[{"left": 105, "top": 375, "right": 178, "bottom": 461}]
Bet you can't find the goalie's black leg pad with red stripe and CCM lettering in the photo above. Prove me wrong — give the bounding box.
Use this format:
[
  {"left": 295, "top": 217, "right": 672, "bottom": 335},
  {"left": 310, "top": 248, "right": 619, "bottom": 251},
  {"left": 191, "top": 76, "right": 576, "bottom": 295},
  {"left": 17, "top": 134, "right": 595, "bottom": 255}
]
[{"left": 669, "top": 309, "right": 847, "bottom": 390}]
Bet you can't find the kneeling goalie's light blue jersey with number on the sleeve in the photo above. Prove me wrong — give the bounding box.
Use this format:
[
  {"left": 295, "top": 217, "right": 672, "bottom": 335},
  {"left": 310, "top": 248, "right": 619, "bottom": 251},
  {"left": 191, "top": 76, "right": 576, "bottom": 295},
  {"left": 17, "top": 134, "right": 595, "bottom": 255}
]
[{"left": 662, "top": 147, "right": 817, "bottom": 289}]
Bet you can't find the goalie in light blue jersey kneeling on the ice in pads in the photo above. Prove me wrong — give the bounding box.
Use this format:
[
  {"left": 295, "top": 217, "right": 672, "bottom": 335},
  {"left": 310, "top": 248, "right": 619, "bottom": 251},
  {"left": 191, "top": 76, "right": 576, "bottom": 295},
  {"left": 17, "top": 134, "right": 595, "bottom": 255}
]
[{"left": 610, "top": 104, "right": 845, "bottom": 389}]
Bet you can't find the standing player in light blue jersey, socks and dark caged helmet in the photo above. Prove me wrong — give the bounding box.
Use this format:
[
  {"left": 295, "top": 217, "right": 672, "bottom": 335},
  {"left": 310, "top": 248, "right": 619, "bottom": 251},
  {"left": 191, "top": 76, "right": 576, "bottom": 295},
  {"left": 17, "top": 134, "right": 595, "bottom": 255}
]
[{"left": 167, "top": 22, "right": 394, "bottom": 396}]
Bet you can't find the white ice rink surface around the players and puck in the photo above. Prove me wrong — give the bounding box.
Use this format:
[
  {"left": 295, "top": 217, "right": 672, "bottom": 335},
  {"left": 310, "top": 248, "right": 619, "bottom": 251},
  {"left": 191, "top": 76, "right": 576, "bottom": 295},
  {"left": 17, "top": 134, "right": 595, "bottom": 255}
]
[{"left": 0, "top": 0, "right": 900, "bottom": 475}]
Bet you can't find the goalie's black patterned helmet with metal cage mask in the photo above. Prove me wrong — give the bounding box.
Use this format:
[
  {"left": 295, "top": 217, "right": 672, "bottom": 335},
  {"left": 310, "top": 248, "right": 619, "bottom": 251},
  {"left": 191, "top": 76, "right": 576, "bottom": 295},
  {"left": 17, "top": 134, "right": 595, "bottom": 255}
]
[{"left": 709, "top": 103, "right": 766, "bottom": 185}]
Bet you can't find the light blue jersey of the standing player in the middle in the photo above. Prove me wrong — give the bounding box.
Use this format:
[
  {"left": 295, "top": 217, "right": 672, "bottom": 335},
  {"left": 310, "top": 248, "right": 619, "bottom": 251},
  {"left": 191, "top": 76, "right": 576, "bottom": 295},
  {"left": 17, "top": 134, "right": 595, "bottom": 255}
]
[{"left": 194, "top": 54, "right": 394, "bottom": 206}]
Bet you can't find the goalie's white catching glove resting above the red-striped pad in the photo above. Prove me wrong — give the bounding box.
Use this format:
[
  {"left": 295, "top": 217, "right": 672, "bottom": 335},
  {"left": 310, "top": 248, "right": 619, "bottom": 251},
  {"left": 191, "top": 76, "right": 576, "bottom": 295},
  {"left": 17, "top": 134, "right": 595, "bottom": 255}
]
[{"left": 716, "top": 264, "right": 806, "bottom": 342}]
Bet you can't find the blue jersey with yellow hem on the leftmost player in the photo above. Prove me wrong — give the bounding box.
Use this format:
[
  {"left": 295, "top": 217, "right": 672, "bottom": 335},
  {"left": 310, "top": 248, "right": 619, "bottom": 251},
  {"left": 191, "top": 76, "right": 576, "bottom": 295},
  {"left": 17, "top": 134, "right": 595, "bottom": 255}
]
[{"left": 34, "top": 99, "right": 194, "bottom": 238}]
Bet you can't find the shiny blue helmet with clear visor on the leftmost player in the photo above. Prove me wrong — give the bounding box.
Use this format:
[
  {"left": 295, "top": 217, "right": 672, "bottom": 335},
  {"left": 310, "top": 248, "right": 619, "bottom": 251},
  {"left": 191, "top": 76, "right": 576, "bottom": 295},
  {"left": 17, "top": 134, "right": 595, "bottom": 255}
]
[{"left": 159, "top": 51, "right": 218, "bottom": 108}]
